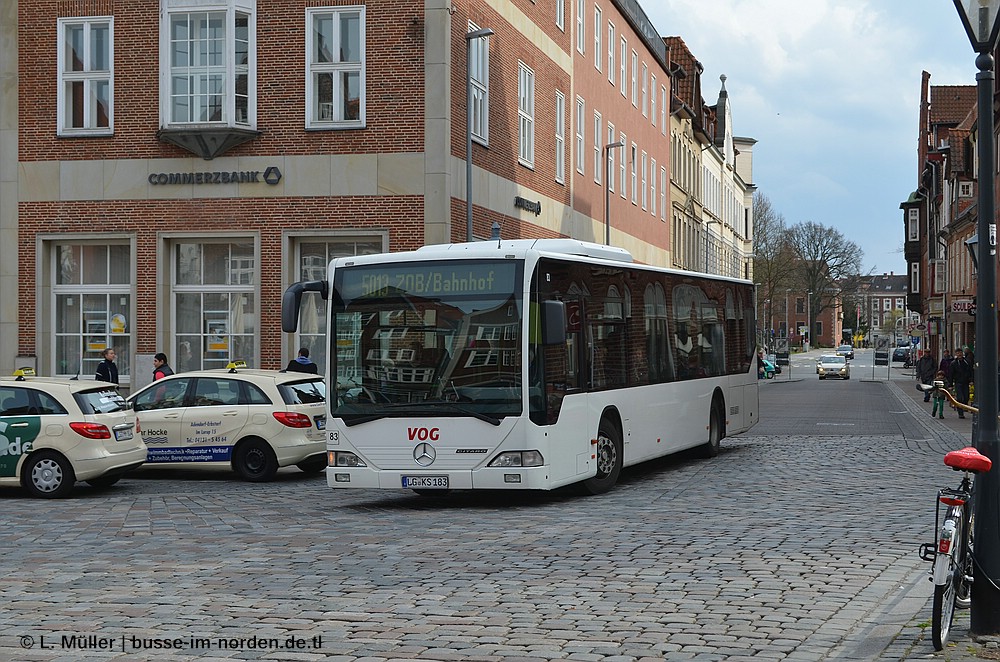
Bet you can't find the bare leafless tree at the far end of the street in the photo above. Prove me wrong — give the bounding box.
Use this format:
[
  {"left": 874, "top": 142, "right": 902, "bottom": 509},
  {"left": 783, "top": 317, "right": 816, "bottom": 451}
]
[{"left": 788, "top": 221, "right": 864, "bottom": 335}]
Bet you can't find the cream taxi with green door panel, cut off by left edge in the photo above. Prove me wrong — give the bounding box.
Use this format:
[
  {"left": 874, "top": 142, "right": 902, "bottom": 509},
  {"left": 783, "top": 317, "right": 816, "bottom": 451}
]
[{"left": 0, "top": 369, "right": 146, "bottom": 499}]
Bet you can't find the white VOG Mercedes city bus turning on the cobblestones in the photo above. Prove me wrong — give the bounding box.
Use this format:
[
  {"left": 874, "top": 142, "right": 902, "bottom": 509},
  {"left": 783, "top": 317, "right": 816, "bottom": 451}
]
[{"left": 282, "top": 239, "right": 758, "bottom": 494}]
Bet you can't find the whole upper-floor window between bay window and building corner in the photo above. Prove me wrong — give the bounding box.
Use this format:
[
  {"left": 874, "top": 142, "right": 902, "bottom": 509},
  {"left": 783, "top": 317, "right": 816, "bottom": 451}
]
[{"left": 306, "top": 6, "right": 368, "bottom": 127}]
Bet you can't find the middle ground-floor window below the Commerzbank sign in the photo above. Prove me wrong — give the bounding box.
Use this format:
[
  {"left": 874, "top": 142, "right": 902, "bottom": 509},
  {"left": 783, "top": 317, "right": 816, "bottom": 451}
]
[{"left": 171, "top": 238, "right": 259, "bottom": 372}]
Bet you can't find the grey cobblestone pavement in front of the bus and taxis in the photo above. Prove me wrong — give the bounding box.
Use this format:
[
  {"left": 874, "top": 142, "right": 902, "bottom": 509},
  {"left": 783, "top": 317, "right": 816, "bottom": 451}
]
[{"left": 0, "top": 382, "right": 992, "bottom": 662}]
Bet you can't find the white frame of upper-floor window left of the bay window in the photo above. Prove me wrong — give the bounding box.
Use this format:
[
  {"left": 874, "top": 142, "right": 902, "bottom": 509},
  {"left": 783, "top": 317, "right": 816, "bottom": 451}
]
[{"left": 56, "top": 16, "right": 115, "bottom": 136}]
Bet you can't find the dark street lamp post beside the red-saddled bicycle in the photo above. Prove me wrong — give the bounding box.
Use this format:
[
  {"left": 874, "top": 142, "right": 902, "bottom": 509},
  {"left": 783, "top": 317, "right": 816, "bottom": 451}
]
[{"left": 955, "top": 0, "right": 1000, "bottom": 635}]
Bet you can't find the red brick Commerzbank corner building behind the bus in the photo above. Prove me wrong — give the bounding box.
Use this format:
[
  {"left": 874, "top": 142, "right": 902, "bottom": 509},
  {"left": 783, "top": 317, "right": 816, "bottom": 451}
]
[{"left": 0, "top": 0, "right": 749, "bottom": 387}]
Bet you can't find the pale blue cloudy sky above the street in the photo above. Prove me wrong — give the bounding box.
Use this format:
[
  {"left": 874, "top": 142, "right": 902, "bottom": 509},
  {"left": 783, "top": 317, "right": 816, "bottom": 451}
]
[{"left": 640, "top": 0, "right": 977, "bottom": 274}]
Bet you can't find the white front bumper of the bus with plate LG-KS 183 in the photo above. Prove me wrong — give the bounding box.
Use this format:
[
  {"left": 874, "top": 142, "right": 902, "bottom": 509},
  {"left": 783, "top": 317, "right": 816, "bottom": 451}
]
[{"left": 326, "top": 466, "right": 553, "bottom": 491}]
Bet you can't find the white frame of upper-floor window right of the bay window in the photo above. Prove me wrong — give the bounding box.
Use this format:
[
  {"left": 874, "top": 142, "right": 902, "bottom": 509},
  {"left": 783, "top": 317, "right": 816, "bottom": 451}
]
[{"left": 305, "top": 5, "right": 370, "bottom": 130}]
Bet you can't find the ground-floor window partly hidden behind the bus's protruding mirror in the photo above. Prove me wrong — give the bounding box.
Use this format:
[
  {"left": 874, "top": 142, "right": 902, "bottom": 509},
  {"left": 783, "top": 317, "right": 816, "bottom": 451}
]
[{"left": 295, "top": 237, "right": 387, "bottom": 374}]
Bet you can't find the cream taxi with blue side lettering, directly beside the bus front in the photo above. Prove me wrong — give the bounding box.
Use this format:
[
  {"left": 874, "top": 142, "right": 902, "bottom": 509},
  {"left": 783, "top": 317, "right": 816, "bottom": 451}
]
[{"left": 128, "top": 362, "right": 326, "bottom": 482}]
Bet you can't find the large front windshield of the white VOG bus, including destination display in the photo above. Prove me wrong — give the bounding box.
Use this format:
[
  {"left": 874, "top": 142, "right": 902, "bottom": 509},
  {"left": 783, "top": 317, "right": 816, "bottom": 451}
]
[{"left": 330, "top": 259, "right": 523, "bottom": 425}]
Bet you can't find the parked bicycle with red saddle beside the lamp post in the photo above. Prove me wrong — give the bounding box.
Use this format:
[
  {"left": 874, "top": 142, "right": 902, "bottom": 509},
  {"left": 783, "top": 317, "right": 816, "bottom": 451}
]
[{"left": 920, "top": 382, "right": 993, "bottom": 650}]
